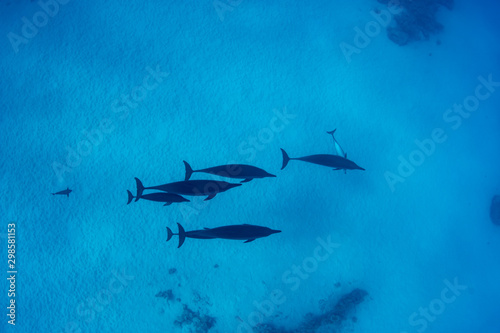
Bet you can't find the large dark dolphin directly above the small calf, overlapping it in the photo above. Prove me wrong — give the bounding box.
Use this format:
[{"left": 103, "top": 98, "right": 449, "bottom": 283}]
[{"left": 135, "top": 178, "right": 241, "bottom": 201}]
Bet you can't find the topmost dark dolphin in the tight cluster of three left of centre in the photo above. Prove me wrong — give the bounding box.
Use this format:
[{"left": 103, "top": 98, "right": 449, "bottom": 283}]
[{"left": 183, "top": 161, "right": 276, "bottom": 183}]
